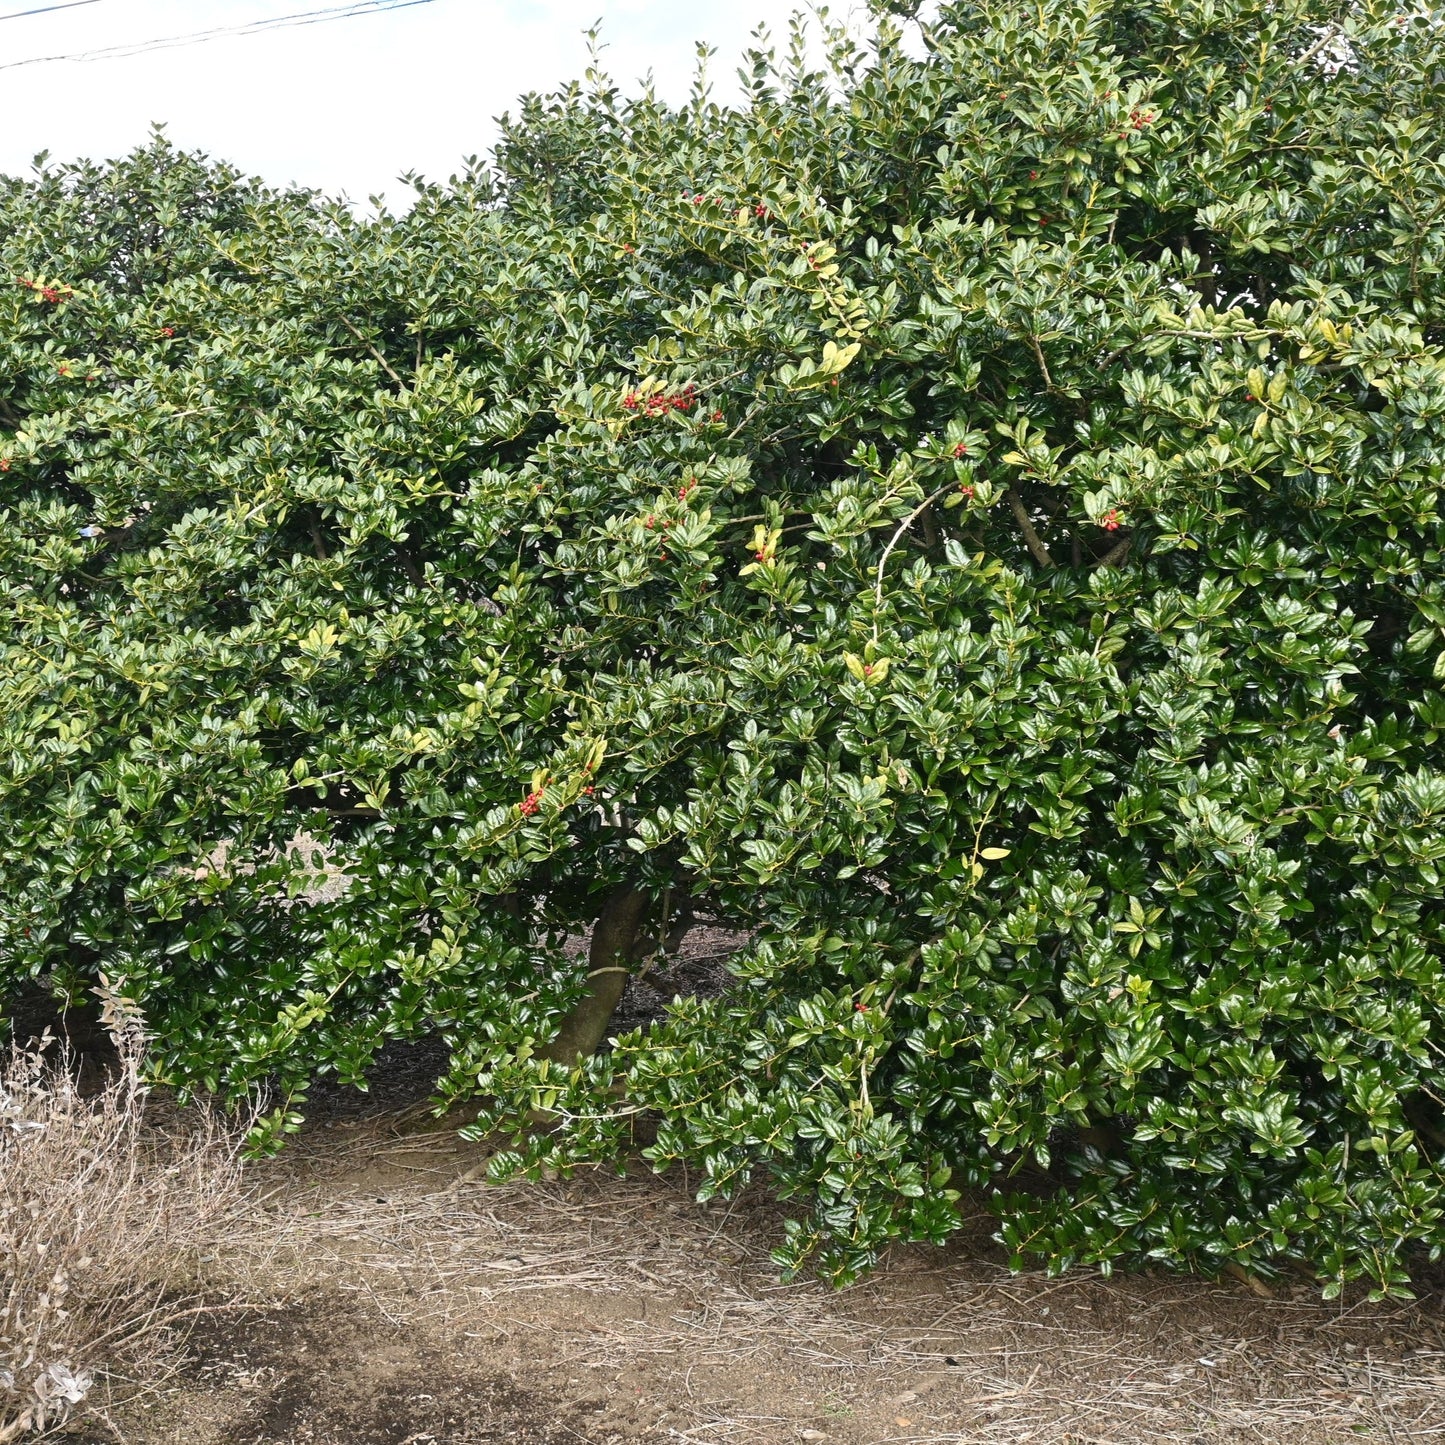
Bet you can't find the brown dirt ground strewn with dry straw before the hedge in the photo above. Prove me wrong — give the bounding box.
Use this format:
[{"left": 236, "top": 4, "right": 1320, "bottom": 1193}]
[{"left": 70, "top": 1028, "right": 1445, "bottom": 1445}]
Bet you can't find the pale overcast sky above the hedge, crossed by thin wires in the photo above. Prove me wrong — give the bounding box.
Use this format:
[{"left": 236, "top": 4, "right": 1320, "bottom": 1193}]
[{"left": 0, "top": 0, "right": 845, "bottom": 212}]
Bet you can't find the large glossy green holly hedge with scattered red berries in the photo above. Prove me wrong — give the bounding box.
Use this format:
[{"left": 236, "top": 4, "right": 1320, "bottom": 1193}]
[{"left": 0, "top": 0, "right": 1445, "bottom": 1293}]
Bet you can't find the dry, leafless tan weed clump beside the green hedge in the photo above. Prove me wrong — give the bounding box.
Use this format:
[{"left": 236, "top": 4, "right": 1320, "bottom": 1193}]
[{"left": 0, "top": 997, "right": 243, "bottom": 1442}]
